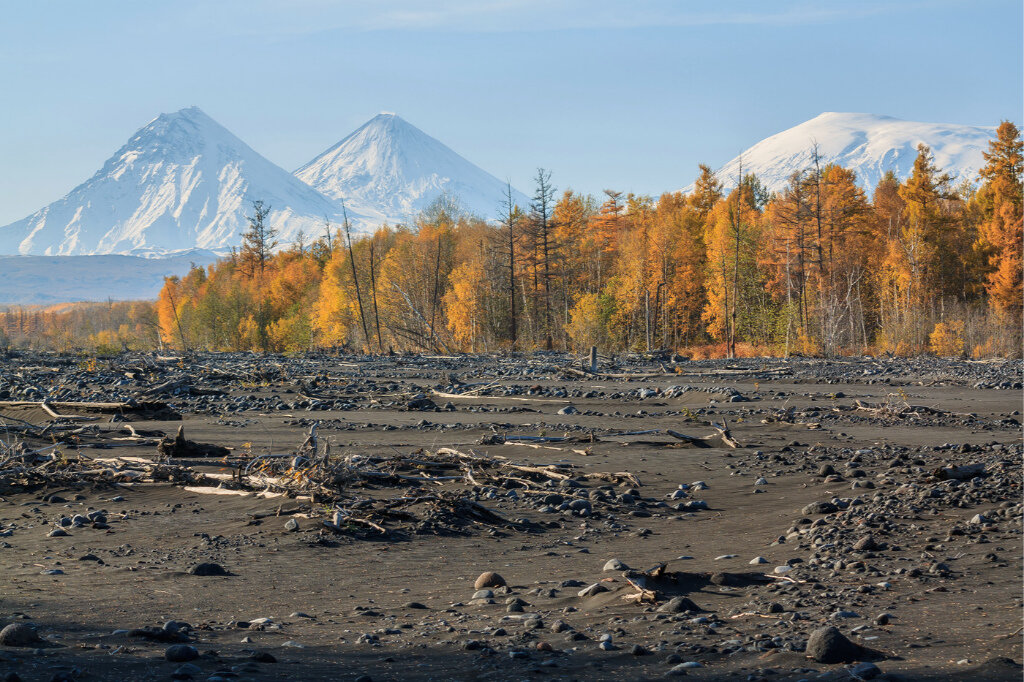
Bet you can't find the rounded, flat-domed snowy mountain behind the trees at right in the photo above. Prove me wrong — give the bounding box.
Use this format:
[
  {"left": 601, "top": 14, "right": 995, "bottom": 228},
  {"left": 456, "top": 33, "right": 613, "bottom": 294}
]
[{"left": 684, "top": 112, "right": 995, "bottom": 191}]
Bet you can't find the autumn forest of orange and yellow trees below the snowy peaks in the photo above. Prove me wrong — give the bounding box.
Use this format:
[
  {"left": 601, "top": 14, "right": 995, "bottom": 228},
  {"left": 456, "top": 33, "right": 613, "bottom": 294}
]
[{"left": 0, "top": 122, "right": 1024, "bottom": 357}]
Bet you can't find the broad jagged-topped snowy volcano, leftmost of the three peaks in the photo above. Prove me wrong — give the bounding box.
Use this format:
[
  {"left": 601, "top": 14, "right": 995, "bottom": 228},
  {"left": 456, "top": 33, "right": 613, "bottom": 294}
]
[{"left": 0, "top": 106, "right": 358, "bottom": 255}]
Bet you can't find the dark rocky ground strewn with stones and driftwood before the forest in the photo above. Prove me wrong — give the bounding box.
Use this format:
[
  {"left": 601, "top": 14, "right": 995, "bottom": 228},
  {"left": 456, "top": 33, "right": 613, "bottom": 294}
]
[{"left": 0, "top": 352, "right": 1024, "bottom": 682}]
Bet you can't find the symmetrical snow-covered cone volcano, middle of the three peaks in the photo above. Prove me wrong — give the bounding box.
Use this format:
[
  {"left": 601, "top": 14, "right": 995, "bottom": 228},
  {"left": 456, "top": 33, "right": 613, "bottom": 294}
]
[{"left": 295, "top": 113, "right": 529, "bottom": 223}]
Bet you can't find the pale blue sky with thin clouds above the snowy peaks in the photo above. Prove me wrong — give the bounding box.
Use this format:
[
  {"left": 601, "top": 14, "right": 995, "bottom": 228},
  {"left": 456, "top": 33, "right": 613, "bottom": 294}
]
[{"left": 0, "top": 0, "right": 1024, "bottom": 225}]
